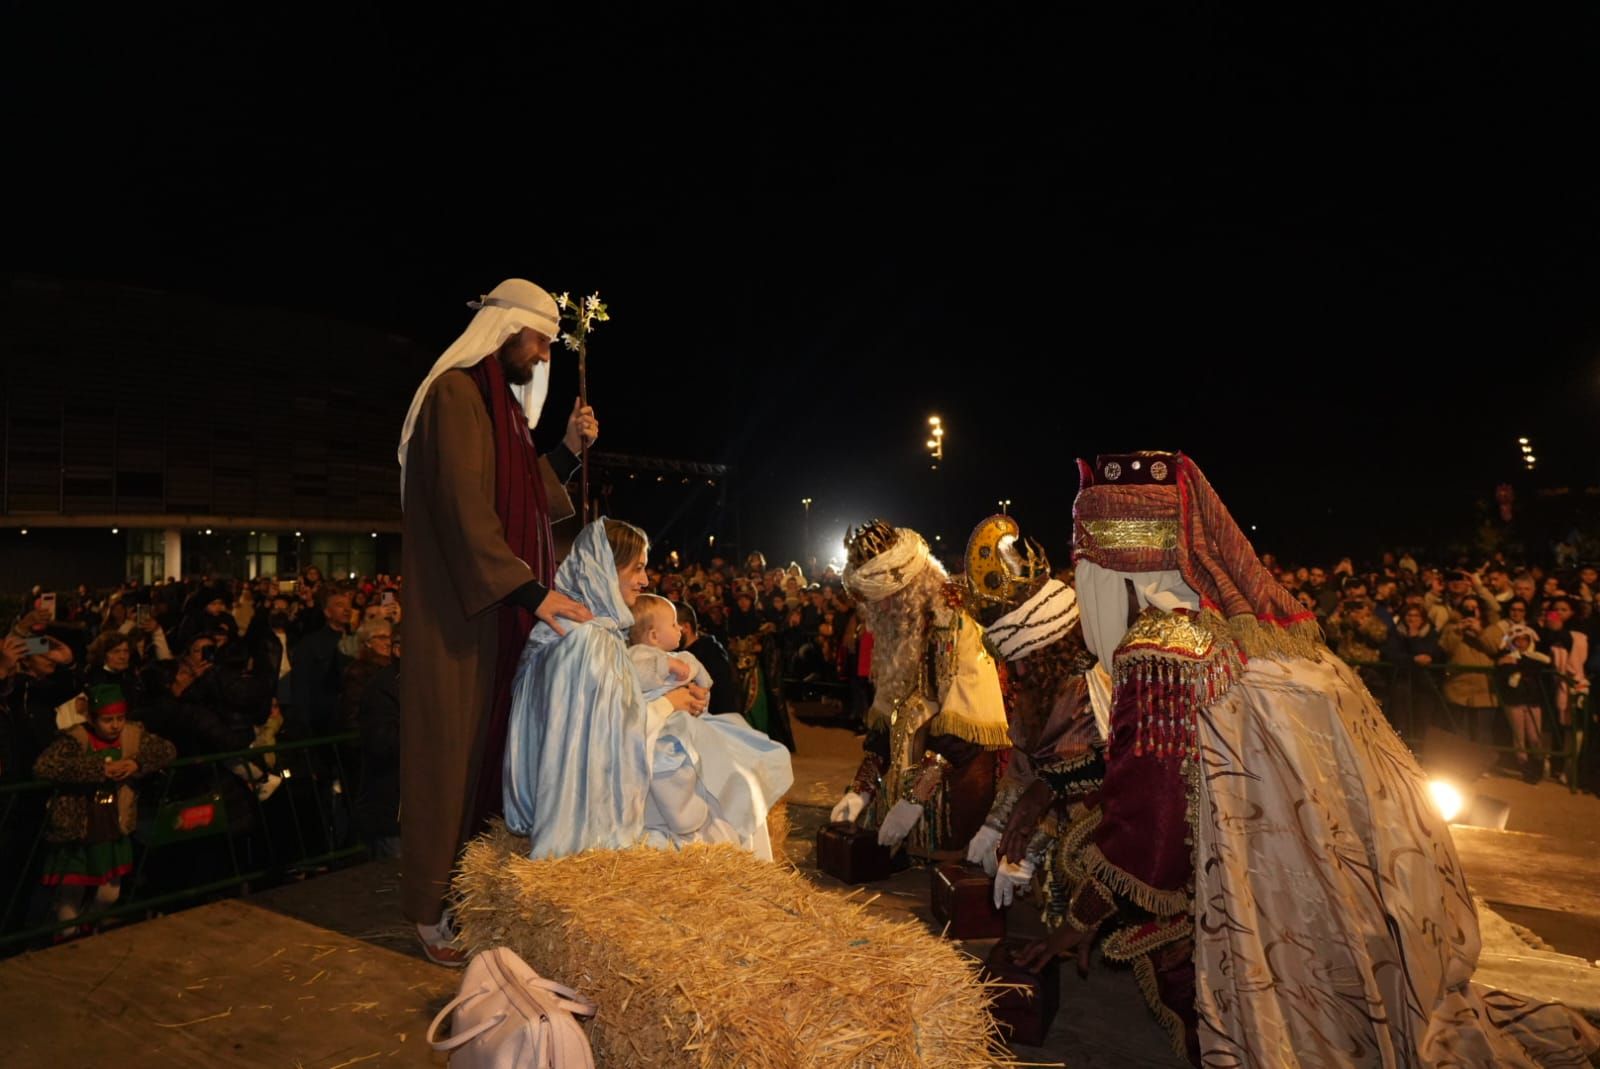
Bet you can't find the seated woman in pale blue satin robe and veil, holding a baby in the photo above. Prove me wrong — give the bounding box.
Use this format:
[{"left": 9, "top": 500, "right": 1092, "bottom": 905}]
[{"left": 506, "top": 517, "right": 794, "bottom": 859}]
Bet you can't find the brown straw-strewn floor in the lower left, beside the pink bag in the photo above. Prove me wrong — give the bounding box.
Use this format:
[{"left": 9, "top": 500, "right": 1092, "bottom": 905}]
[{"left": 0, "top": 883, "right": 461, "bottom": 1069}]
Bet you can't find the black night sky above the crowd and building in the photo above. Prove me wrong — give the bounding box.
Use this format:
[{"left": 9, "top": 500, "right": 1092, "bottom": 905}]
[{"left": 3, "top": 3, "right": 1600, "bottom": 557}]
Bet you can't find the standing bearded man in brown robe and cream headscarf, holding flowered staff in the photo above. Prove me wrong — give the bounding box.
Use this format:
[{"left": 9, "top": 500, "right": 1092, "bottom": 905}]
[{"left": 400, "top": 278, "right": 598, "bottom": 967}]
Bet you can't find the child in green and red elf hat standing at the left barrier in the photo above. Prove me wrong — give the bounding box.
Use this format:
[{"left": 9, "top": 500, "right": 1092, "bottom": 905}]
[{"left": 34, "top": 685, "right": 178, "bottom": 939}]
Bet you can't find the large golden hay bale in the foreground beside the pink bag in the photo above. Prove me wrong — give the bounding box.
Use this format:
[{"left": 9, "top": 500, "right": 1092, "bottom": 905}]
[{"left": 454, "top": 824, "right": 1013, "bottom": 1069}]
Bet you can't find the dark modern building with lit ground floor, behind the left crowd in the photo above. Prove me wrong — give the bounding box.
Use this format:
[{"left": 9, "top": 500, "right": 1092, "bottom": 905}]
[{"left": 0, "top": 275, "right": 432, "bottom": 591}]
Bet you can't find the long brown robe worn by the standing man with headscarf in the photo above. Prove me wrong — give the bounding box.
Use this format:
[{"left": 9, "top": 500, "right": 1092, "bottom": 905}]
[{"left": 400, "top": 369, "right": 573, "bottom": 925}]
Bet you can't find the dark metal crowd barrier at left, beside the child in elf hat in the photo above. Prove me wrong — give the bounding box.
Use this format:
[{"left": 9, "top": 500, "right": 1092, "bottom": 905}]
[{"left": 0, "top": 733, "right": 366, "bottom": 955}]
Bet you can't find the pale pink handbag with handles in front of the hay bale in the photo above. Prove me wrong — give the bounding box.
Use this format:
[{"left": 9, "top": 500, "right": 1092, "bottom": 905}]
[{"left": 427, "top": 946, "right": 595, "bottom": 1069}]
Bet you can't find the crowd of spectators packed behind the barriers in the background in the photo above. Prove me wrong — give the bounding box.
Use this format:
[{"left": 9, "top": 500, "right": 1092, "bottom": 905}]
[{"left": 0, "top": 554, "right": 1600, "bottom": 940}]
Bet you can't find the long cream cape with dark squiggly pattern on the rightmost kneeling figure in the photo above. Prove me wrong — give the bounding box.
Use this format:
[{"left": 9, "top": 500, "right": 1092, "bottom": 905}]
[{"left": 1192, "top": 656, "right": 1600, "bottom": 1069}]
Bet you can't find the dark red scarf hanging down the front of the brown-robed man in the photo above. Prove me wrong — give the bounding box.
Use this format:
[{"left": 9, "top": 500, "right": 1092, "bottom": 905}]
[{"left": 466, "top": 354, "right": 555, "bottom": 834}]
